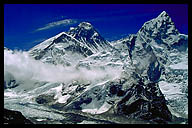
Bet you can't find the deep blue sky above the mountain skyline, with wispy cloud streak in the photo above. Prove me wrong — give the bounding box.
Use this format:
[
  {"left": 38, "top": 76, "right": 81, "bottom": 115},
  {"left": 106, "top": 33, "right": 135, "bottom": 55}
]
[{"left": 4, "top": 4, "right": 188, "bottom": 50}]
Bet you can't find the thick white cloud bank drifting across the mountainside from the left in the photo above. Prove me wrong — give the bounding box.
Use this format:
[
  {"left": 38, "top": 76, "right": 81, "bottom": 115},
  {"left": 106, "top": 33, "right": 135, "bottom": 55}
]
[{"left": 4, "top": 50, "right": 121, "bottom": 83}]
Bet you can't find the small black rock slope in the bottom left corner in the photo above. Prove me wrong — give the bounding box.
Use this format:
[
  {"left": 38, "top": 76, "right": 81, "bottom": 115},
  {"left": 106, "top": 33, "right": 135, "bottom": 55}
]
[{"left": 3, "top": 109, "right": 33, "bottom": 124}]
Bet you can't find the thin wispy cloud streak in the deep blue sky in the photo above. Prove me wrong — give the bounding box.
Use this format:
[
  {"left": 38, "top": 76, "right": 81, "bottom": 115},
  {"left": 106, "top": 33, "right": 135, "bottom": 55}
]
[{"left": 35, "top": 19, "right": 77, "bottom": 31}]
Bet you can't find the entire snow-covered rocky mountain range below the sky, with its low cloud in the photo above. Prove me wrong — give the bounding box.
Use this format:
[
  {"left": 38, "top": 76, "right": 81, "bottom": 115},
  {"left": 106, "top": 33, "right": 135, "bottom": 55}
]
[{"left": 4, "top": 11, "right": 188, "bottom": 124}]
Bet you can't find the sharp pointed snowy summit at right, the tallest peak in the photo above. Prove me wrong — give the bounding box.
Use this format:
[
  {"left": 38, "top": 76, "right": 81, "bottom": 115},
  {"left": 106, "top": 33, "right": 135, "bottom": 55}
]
[{"left": 137, "top": 11, "right": 180, "bottom": 46}]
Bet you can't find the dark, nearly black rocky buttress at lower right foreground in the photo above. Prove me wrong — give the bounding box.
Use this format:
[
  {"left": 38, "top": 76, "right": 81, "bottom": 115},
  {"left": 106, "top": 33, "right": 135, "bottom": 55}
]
[{"left": 116, "top": 82, "right": 172, "bottom": 123}]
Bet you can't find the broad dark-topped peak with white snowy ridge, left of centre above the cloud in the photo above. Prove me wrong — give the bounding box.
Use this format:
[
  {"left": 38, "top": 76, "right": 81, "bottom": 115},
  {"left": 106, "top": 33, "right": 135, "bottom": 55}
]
[{"left": 29, "top": 22, "right": 110, "bottom": 66}]
